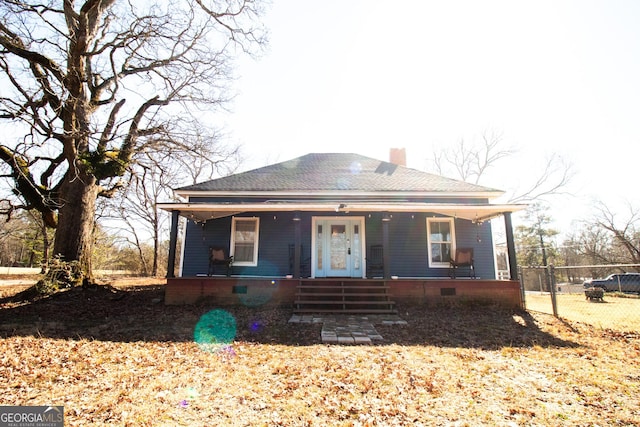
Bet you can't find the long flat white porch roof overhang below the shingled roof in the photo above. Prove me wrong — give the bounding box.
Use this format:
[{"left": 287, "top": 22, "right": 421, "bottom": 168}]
[{"left": 158, "top": 201, "right": 527, "bottom": 222}]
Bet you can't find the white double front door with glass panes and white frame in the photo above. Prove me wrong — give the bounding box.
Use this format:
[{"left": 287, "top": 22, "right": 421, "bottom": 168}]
[{"left": 313, "top": 217, "right": 364, "bottom": 277}]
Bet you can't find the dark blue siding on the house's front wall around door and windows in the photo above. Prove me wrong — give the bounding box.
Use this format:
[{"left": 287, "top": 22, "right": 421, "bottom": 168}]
[{"left": 182, "top": 212, "right": 495, "bottom": 279}]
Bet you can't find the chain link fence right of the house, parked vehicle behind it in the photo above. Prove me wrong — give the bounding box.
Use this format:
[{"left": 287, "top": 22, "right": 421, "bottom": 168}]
[{"left": 519, "top": 264, "right": 640, "bottom": 332}]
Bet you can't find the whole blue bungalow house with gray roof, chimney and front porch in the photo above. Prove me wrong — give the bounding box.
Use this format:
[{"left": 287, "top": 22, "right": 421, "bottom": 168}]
[{"left": 159, "top": 150, "right": 524, "bottom": 312}]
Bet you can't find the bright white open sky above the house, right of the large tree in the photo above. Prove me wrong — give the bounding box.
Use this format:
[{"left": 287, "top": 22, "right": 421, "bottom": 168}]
[{"left": 218, "top": 0, "right": 640, "bottom": 234}]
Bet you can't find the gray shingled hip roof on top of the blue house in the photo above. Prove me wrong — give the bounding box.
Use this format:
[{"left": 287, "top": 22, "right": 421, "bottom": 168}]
[{"left": 177, "top": 153, "right": 500, "bottom": 193}]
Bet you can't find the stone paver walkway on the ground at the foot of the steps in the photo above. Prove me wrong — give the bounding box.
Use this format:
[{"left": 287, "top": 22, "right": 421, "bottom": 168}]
[{"left": 289, "top": 314, "right": 407, "bottom": 344}]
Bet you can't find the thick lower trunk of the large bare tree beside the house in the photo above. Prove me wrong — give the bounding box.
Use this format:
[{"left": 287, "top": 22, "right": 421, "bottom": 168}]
[{"left": 54, "top": 173, "right": 99, "bottom": 281}]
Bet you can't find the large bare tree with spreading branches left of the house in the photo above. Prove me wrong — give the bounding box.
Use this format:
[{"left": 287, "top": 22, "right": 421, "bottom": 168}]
[{"left": 0, "top": 0, "right": 265, "bottom": 284}]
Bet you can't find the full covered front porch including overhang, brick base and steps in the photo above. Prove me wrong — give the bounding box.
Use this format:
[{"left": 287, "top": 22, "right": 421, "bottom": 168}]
[{"left": 162, "top": 196, "right": 522, "bottom": 313}]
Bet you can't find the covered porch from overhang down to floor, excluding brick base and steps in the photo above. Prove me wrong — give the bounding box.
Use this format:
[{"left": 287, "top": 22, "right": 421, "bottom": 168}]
[{"left": 161, "top": 201, "right": 521, "bottom": 280}]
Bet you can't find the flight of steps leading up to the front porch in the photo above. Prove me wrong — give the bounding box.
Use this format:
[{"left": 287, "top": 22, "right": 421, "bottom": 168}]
[{"left": 294, "top": 279, "right": 397, "bottom": 314}]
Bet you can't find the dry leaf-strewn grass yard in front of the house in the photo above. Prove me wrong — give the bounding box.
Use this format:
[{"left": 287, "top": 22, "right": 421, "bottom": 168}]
[{"left": 0, "top": 286, "right": 640, "bottom": 426}]
